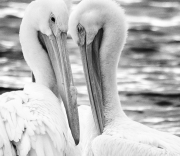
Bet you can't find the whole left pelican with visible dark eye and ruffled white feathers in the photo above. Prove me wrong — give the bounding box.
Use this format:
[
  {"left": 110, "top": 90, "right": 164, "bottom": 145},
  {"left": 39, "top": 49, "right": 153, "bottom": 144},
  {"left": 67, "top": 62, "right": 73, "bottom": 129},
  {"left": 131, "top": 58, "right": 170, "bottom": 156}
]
[{"left": 0, "top": 0, "right": 80, "bottom": 156}]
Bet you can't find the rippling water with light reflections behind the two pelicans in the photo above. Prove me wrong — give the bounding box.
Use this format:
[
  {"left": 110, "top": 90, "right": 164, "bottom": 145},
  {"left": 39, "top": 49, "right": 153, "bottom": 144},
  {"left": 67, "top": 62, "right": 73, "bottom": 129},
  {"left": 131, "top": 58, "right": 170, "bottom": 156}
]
[{"left": 0, "top": 0, "right": 180, "bottom": 135}]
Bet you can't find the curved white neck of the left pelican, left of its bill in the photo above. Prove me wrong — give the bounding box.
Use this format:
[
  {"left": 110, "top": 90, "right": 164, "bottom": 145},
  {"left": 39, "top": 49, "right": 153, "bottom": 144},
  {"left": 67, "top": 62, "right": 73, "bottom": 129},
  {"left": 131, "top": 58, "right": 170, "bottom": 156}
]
[{"left": 19, "top": 17, "right": 58, "bottom": 96}]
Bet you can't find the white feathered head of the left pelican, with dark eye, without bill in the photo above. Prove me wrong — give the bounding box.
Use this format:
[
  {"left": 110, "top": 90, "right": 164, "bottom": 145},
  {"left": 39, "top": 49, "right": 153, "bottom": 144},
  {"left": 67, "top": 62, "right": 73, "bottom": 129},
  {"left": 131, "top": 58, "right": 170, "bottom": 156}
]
[{"left": 23, "top": 0, "right": 69, "bottom": 36}]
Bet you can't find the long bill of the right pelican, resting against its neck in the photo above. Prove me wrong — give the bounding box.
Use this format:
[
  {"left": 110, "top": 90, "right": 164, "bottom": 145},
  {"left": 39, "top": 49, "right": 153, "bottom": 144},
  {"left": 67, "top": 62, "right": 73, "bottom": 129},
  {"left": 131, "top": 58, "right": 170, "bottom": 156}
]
[{"left": 78, "top": 24, "right": 104, "bottom": 134}]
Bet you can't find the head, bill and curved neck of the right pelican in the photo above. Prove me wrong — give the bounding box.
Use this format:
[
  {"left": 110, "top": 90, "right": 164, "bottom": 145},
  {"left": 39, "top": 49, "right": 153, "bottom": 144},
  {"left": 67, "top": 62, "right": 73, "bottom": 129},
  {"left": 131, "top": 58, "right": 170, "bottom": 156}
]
[{"left": 69, "top": 0, "right": 127, "bottom": 133}]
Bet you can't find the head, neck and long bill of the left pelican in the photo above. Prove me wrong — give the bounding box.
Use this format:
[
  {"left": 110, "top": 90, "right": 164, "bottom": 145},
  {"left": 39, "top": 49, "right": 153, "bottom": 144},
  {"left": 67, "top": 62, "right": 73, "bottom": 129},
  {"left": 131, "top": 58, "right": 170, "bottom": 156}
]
[{"left": 20, "top": 0, "right": 79, "bottom": 144}]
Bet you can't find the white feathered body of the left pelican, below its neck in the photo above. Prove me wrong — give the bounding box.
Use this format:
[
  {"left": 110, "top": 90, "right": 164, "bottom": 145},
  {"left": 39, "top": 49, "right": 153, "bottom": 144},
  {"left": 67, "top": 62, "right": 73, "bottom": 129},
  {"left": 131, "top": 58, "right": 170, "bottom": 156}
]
[{"left": 0, "top": 83, "right": 75, "bottom": 156}]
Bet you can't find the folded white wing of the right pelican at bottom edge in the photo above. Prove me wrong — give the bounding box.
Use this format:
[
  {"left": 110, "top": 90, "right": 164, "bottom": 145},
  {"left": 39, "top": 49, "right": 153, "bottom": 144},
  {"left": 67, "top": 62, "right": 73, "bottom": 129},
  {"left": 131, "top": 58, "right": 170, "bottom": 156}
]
[{"left": 89, "top": 135, "right": 177, "bottom": 156}]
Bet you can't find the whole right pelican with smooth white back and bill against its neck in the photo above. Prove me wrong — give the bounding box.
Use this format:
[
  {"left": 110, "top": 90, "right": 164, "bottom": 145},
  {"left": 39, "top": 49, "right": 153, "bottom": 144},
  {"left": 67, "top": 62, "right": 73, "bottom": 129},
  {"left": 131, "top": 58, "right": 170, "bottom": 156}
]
[{"left": 69, "top": 0, "right": 180, "bottom": 156}]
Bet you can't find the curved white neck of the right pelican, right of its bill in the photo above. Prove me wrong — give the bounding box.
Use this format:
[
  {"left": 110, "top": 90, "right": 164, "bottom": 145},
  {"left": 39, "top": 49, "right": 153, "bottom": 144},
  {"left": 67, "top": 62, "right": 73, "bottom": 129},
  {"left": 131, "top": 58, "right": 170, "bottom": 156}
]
[{"left": 100, "top": 13, "right": 127, "bottom": 125}]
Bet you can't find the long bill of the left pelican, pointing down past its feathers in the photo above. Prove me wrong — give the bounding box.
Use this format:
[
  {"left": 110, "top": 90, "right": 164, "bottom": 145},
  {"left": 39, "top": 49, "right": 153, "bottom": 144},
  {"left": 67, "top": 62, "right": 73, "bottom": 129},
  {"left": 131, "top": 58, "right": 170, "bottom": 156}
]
[{"left": 36, "top": 18, "right": 80, "bottom": 145}]
